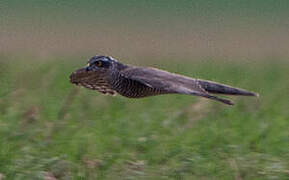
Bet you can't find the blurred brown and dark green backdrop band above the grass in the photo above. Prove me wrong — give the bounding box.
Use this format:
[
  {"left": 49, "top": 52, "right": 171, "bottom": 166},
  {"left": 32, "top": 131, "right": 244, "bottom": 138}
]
[{"left": 0, "top": 0, "right": 289, "bottom": 59}]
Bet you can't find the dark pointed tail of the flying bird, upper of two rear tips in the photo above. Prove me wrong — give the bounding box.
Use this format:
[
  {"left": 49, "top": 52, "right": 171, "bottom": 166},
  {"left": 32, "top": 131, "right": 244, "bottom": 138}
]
[{"left": 198, "top": 80, "right": 259, "bottom": 96}]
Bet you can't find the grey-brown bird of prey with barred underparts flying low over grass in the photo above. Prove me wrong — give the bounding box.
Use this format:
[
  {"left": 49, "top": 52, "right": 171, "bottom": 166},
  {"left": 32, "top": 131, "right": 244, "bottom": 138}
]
[{"left": 70, "top": 55, "right": 258, "bottom": 105}]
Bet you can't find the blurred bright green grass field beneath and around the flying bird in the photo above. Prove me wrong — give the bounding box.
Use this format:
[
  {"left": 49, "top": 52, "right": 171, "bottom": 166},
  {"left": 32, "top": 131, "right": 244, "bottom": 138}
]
[{"left": 0, "top": 57, "right": 289, "bottom": 180}]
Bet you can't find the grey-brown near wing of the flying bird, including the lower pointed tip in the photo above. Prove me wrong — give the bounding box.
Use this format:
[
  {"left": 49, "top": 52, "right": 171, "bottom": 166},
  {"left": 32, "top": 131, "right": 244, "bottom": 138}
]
[{"left": 121, "top": 67, "right": 233, "bottom": 105}]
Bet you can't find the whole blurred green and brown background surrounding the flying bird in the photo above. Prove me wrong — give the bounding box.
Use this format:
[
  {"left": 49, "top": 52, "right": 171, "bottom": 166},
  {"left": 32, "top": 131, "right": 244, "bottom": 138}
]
[{"left": 0, "top": 0, "right": 289, "bottom": 180}]
